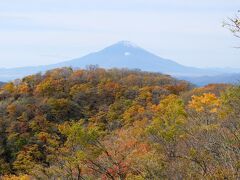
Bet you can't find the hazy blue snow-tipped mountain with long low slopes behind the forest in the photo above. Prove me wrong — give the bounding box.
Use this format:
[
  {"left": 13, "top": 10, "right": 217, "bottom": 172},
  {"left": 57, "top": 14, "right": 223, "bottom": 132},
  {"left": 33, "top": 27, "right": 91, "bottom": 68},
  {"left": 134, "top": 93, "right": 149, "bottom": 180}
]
[{"left": 0, "top": 41, "right": 240, "bottom": 86}]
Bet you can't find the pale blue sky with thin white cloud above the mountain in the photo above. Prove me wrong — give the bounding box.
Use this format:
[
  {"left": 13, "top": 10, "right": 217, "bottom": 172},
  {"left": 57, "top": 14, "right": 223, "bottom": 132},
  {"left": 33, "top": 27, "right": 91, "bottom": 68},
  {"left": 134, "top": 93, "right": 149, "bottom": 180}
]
[{"left": 0, "top": 0, "right": 240, "bottom": 68}]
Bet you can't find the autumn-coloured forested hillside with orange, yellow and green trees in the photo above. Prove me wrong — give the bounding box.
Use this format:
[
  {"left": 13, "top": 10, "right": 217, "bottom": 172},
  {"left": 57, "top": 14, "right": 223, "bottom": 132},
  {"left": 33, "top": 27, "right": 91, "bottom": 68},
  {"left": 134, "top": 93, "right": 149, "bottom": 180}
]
[{"left": 0, "top": 66, "right": 240, "bottom": 180}]
